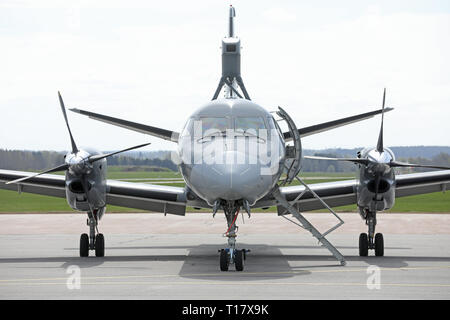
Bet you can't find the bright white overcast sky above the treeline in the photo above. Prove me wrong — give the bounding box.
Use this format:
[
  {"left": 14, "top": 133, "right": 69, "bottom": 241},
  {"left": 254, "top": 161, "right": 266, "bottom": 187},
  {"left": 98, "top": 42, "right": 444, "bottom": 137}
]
[{"left": 0, "top": 0, "right": 450, "bottom": 150}]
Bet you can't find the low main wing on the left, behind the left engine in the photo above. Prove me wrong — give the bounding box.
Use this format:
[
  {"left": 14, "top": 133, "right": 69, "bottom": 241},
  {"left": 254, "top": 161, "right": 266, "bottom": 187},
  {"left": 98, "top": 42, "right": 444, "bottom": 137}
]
[{"left": 0, "top": 170, "right": 189, "bottom": 215}]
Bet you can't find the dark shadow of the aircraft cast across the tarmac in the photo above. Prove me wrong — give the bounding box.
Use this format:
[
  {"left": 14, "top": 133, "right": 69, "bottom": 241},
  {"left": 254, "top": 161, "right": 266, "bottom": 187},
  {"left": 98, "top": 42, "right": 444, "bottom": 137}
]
[{"left": 0, "top": 243, "right": 450, "bottom": 281}]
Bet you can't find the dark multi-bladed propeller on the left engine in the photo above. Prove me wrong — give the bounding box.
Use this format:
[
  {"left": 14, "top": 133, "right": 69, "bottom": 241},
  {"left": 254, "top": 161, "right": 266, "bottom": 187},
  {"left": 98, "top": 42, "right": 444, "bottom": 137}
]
[{"left": 6, "top": 91, "right": 150, "bottom": 192}]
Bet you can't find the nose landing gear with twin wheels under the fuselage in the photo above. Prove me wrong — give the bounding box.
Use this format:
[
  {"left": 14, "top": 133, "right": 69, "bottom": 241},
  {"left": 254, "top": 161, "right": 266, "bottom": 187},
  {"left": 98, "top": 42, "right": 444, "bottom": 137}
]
[{"left": 219, "top": 203, "right": 250, "bottom": 271}]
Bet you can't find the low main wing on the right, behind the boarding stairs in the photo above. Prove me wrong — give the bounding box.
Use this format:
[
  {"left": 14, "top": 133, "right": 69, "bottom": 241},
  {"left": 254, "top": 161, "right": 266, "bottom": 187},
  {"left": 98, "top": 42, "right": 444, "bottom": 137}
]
[{"left": 255, "top": 170, "right": 450, "bottom": 214}]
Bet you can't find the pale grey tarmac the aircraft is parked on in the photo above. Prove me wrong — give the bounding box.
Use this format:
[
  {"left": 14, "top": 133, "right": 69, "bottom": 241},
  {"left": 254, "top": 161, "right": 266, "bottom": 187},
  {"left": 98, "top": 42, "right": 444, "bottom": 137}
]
[{"left": 0, "top": 213, "right": 450, "bottom": 300}]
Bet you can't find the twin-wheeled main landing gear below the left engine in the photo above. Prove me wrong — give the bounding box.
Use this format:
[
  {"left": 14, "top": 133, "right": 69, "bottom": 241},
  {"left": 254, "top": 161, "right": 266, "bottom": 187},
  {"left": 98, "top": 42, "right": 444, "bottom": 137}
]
[{"left": 80, "top": 213, "right": 105, "bottom": 257}]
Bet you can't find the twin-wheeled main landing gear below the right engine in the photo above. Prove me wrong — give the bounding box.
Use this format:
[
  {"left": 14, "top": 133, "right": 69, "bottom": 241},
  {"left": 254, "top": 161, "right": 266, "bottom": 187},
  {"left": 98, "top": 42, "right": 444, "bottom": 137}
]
[{"left": 359, "top": 211, "right": 384, "bottom": 257}]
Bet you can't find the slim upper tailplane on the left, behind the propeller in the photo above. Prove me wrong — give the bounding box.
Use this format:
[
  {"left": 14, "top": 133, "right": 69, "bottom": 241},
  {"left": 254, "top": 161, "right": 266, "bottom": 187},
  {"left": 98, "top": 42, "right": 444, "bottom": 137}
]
[{"left": 69, "top": 108, "right": 179, "bottom": 142}]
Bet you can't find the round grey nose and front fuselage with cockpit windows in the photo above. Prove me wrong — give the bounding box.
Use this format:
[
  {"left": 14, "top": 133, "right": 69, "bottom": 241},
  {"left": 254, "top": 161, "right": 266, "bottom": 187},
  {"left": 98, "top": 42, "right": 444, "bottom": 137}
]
[{"left": 178, "top": 98, "right": 286, "bottom": 206}]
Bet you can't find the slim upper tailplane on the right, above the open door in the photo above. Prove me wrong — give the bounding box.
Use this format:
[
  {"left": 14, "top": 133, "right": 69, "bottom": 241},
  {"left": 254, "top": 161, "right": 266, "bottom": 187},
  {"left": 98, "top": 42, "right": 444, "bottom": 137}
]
[{"left": 283, "top": 108, "right": 394, "bottom": 141}]
